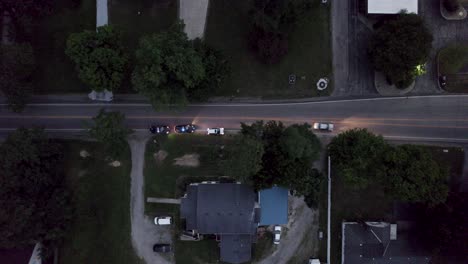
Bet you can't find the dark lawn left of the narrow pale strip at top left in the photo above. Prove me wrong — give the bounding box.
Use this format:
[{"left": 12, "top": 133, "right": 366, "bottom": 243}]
[{"left": 31, "top": 0, "right": 96, "bottom": 94}]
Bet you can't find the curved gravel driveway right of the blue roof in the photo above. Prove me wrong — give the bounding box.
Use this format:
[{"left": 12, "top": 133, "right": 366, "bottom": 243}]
[{"left": 258, "top": 196, "right": 318, "bottom": 264}]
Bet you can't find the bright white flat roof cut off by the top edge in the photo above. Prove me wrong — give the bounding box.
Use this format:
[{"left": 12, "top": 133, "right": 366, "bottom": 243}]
[{"left": 367, "top": 0, "right": 418, "bottom": 14}]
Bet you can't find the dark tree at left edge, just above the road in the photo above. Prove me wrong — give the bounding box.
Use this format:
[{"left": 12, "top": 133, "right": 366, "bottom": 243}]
[{"left": 0, "top": 43, "right": 35, "bottom": 112}]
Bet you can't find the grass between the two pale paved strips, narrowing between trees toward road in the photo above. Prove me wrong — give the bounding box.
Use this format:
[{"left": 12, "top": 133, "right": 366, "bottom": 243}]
[{"left": 109, "top": 0, "right": 178, "bottom": 93}]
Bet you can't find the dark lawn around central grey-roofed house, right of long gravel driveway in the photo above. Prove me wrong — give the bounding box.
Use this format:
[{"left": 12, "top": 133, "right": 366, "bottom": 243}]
[{"left": 144, "top": 134, "right": 229, "bottom": 264}]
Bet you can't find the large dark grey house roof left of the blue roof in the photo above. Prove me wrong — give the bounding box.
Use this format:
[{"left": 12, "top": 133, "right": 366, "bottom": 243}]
[{"left": 180, "top": 182, "right": 260, "bottom": 263}]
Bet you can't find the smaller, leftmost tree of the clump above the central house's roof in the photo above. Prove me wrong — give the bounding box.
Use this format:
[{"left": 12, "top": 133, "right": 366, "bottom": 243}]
[{"left": 221, "top": 135, "right": 264, "bottom": 183}]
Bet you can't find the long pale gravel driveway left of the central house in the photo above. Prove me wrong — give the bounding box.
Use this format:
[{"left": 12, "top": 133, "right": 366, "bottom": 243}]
[{"left": 129, "top": 136, "right": 173, "bottom": 264}]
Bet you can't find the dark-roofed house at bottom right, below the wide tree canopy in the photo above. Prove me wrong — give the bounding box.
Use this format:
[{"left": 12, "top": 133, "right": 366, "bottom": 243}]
[{"left": 341, "top": 222, "right": 431, "bottom": 264}]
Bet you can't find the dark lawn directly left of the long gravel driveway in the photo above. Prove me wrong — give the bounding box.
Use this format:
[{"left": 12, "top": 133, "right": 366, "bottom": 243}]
[{"left": 59, "top": 141, "right": 143, "bottom": 264}]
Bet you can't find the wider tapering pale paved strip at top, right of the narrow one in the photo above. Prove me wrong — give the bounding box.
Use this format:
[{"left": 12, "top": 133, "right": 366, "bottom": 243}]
[{"left": 179, "top": 0, "right": 209, "bottom": 39}]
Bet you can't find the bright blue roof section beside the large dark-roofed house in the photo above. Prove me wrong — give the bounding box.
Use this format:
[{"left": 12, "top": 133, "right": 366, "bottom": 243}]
[{"left": 258, "top": 186, "right": 288, "bottom": 225}]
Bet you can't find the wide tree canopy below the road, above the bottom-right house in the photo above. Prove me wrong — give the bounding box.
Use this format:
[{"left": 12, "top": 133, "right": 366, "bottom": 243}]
[{"left": 329, "top": 129, "right": 448, "bottom": 205}]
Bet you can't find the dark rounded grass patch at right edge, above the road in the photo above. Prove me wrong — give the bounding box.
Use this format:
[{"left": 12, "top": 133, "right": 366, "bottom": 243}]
[{"left": 438, "top": 44, "right": 468, "bottom": 93}]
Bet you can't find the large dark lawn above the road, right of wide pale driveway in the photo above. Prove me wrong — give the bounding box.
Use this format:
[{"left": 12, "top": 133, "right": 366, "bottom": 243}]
[{"left": 205, "top": 0, "right": 332, "bottom": 98}]
